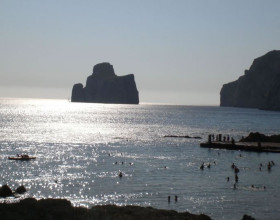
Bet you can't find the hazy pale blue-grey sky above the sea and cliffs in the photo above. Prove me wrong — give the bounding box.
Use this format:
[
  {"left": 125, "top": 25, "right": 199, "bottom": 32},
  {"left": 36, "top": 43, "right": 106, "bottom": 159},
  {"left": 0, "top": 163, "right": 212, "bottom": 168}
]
[{"left": 0, "top": 0, "right": 280, "bottom": 105}]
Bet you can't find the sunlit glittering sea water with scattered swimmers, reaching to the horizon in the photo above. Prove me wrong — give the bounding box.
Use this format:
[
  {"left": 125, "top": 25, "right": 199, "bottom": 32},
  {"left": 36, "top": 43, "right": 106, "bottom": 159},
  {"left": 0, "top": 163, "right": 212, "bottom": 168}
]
[{"left": 0, "top": 99, "right": 280, "bottom": 220}]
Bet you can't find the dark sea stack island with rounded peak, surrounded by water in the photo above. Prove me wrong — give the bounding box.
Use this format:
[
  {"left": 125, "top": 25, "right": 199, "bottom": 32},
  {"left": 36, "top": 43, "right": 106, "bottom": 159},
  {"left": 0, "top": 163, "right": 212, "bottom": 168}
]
[{"left": 71, "top": 63, "right": 139, "bottom": 104}]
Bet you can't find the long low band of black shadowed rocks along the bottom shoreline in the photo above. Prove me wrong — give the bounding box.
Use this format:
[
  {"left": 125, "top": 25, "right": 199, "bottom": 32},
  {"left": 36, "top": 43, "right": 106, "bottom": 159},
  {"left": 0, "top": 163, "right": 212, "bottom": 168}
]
[{"left": 0, "top": 198, "right": 211, "bottom": 220}]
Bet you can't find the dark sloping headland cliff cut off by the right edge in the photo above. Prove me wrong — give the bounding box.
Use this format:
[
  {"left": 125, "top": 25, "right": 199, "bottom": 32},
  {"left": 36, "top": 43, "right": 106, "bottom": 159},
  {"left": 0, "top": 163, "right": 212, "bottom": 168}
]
[{"left": 220, "top": 50, "right": 280, "bottom": 111}]
